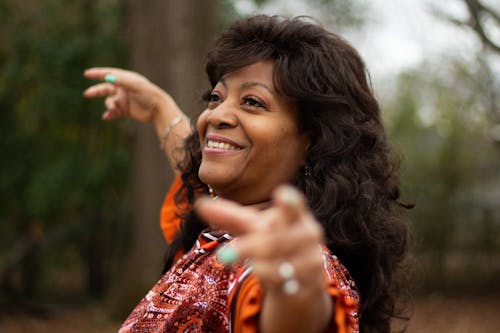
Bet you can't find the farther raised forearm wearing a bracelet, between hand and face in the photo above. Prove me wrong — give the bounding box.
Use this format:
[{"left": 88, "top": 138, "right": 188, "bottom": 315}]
[{"left": 153, "top": 93, "right": 192, "bottom": 171}]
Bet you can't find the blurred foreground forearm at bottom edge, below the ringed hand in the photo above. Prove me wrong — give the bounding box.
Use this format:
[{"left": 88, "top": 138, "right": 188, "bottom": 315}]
[{"left": 260, "top": 287, "right": 333, "bottom": 333}]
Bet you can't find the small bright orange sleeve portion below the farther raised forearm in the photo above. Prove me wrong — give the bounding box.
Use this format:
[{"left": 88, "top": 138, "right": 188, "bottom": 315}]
[{"left": 160, "top": 175, "right": 185, "bottom": 243}]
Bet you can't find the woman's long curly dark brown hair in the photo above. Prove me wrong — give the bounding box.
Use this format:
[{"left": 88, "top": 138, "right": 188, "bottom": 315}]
[{"left": 164, "top": 15, "right": 409, "bottom": 332}]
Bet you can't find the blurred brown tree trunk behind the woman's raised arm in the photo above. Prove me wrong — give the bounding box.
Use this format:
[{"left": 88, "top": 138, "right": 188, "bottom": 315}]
[{"left": 111, "top": 0, "right": 217, "bottom": 315}]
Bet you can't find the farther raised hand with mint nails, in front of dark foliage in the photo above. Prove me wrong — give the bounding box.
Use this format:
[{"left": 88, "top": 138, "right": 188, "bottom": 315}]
[{"left": 83, "top": 67, "right": 170, "bottom": 123}]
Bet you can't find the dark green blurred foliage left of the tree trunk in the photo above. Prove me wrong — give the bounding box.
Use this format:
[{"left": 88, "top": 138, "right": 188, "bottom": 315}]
[{"left": 0, "top": 0, "right": 130, "bottom": 296}]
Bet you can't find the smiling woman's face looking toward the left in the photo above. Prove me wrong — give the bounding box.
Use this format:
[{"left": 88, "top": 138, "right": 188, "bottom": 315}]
[{"left": 197, "top": 61, "right": 309, "bottom": 204}]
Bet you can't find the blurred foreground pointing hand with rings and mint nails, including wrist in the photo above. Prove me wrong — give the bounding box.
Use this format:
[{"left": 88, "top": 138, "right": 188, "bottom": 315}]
[{"left": 196, "top": 186, "right": 331, "bottom": 332}]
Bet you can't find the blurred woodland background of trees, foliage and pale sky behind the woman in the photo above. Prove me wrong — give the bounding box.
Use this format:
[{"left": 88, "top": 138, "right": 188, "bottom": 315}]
[{"left": 0, "top": 0, "right": 500, "bottom": 333}]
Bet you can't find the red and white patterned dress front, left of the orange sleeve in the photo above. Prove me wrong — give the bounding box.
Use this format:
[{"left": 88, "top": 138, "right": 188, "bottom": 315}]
[{"left": 119, "top": 233, "right": 234, "bottom": 333}]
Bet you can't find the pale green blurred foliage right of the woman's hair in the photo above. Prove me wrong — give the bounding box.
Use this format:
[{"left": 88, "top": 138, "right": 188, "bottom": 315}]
[{"left": 385, "top": 53, "right": 500, "bottom": 288}]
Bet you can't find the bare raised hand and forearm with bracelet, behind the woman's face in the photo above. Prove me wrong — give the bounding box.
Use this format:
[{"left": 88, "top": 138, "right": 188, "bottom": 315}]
[{"left": 83, "top": 67, "right": 191, "bottom": 171}]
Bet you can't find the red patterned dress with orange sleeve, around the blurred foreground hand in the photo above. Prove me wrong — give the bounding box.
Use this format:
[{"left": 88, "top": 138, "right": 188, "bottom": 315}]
[{"left": 119, "top": 228, "right": 359, "bottom": 333}]
